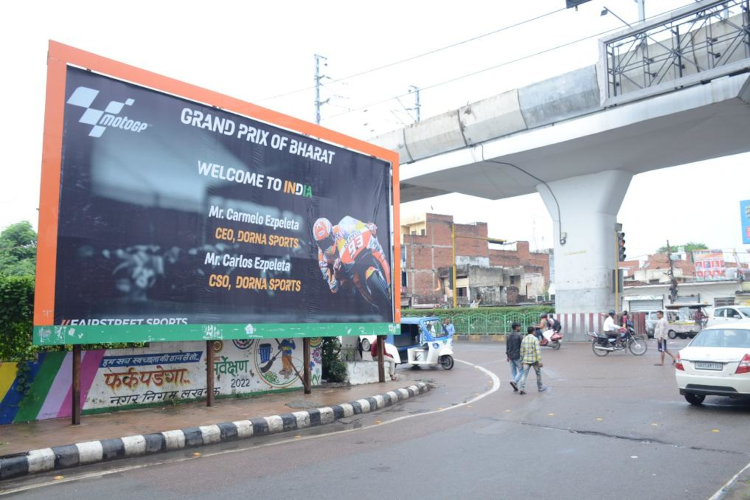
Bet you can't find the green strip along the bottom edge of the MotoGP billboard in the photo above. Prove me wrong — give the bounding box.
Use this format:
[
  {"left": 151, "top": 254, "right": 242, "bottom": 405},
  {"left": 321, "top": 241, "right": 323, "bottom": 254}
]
[{"left": 34, "top": 323, "right": 400, "bottom": 345}]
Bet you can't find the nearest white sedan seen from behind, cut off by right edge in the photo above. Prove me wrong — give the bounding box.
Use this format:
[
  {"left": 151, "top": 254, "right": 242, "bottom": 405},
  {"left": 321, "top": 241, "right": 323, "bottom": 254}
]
[{"left": 675, "top": 321, "right": 750, "bottom": 405}]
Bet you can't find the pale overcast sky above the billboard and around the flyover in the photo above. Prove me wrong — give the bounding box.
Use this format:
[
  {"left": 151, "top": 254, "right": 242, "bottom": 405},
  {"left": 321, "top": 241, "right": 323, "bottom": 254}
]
[{"left": 0, "top": 0, "right": 750, "bottom": 257}]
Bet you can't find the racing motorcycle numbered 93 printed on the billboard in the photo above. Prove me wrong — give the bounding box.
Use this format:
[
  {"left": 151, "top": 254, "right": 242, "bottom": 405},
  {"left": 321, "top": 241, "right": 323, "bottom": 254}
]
[{"left": 339, "top": 227, "right": 391, "bottom": 313}]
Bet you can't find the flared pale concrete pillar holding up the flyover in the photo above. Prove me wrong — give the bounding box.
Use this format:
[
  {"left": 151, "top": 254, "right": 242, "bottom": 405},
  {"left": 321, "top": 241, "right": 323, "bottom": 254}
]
[{"left": 536, "top": 170, "right": 633, "bottom": 340}]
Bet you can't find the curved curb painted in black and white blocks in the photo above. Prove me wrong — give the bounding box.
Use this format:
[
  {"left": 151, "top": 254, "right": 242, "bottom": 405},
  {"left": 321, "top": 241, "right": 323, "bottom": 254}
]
[{"left": 0, "top": 382, "right": 430, "bottom": 481}]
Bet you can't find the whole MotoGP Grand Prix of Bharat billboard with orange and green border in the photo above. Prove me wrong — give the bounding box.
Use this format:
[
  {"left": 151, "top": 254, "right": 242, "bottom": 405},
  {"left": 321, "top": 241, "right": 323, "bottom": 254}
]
[{"left": 34, "top": 42, "right": 400, "bottom": 344}]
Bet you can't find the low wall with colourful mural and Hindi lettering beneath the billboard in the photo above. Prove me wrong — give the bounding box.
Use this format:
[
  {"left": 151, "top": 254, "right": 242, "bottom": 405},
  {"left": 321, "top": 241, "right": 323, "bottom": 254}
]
[{"left": 0, "top": 338, "right": 322, "bottom": 424}]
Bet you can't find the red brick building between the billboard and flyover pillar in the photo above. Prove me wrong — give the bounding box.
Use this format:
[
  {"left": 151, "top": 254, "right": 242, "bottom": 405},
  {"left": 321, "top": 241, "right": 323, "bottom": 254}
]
[{"left": 401, "top": 214, "right": 550, "bottom": 307}]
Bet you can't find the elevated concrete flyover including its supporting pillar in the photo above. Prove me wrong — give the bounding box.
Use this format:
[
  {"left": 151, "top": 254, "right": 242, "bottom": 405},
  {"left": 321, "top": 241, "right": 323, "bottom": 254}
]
[{"left": 373, "top": 0, "right": 750, "bottom": 338}]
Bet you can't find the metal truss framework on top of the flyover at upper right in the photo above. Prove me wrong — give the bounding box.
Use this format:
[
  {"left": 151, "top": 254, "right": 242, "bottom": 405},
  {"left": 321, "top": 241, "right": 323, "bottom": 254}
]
[{"left": 601, "top": 0, "right": 750, "bottom": 99}]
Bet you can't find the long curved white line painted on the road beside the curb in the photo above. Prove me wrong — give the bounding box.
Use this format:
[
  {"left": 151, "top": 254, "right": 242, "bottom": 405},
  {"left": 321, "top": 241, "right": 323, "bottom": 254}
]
[{"left": 0, "top": 358, "right": 500, "bottom": 496}]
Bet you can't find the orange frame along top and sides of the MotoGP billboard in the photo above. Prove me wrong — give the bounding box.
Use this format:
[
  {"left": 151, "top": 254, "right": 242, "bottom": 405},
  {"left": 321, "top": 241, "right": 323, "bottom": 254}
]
[{"left": 34, "top": 41, "right": 401, "bottom": 341}]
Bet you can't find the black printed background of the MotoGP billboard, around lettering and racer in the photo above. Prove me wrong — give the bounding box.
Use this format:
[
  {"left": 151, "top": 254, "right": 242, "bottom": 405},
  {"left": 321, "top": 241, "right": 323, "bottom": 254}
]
[{"left": 55, "top": 67, "right": 393, "bottom": 324}]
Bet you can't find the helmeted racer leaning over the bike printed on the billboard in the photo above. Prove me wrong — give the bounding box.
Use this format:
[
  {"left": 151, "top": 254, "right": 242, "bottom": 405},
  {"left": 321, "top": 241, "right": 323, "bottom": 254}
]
[{"left": 313, "top": 215, "right": 391, "bottom": 293}]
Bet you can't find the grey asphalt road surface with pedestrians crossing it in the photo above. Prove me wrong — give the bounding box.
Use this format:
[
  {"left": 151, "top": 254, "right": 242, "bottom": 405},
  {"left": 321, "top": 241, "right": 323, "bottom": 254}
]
[{"left": 0, "top": 340, "right": 750, "bottom": 500}]
